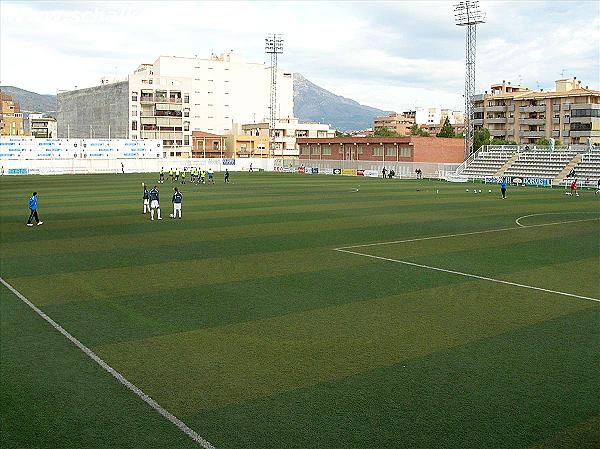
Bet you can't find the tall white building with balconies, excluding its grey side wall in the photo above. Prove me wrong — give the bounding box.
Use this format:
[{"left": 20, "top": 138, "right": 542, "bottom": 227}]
[{"left": 128, "top": 52, "right": 294, "bottom": 156}]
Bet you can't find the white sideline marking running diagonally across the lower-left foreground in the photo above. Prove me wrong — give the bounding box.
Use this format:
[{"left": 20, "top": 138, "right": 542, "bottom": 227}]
[{"left": 0, "top": 277, "right": 215, "bottom": 449}]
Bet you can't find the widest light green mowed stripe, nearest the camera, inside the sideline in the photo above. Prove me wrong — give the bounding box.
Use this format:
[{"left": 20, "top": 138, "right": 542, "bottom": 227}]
[{"left": 94, "top": 281, "right": 594, "bottom": 414}]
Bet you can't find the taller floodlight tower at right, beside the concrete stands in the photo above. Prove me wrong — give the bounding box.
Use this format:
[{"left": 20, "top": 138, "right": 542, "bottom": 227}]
[{"left": 454, "top": 0, "right": 485, "bottom": 159}]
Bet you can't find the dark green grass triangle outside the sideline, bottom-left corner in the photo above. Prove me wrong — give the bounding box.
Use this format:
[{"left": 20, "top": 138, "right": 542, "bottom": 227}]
[{"left": 0, "top": 286, "right": 198, "bottom": 449}]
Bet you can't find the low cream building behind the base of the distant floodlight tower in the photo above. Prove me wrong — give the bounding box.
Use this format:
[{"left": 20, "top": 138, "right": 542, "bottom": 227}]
[{"left": 241, "top": 117, "right": 335, "bottom": 157}]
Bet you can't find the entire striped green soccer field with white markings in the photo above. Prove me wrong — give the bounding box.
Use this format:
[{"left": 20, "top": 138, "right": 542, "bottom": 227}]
[{"left": 0, "top": 173, "right": 600, "bottom": 449}]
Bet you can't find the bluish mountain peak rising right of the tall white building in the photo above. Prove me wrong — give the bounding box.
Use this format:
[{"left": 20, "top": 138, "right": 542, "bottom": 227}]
[{"left": 294, "top": 73, "right": 389, "bottom": 131}]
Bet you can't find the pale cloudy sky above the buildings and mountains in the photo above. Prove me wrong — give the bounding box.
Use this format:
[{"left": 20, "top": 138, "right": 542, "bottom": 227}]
[{"left": 0, "top": 0, "right": 600, "bottom": 111}]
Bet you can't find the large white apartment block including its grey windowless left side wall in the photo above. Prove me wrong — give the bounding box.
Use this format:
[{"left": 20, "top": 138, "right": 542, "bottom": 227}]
[{"left": 58, "top": 51, "right": 293, "bottom": 157}]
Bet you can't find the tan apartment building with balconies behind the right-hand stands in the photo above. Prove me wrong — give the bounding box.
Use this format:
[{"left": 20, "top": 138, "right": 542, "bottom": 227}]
[{"left": 472, "top": 78, "right": 600, "bottom": 145}]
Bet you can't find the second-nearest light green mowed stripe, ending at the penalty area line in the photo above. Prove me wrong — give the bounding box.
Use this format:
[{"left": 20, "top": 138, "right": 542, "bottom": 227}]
[{"left": 3, "top": 249, "right": 377, "bottom": 305}]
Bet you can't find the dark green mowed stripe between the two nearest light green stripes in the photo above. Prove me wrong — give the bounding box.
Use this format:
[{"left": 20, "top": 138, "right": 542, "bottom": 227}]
[{"left": 39, "top": 264, "right": 482, "bottom": 346}]
